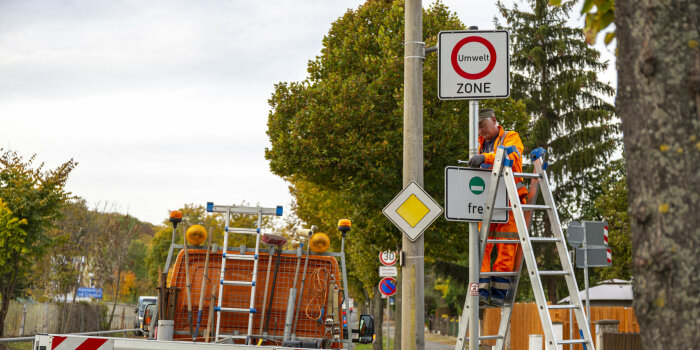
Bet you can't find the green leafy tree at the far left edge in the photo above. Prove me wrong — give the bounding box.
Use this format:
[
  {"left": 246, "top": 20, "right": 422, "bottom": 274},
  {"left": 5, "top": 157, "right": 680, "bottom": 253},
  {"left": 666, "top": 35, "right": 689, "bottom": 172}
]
[{"left": 0, "top": 149, "right": 77, "bottom": 337}]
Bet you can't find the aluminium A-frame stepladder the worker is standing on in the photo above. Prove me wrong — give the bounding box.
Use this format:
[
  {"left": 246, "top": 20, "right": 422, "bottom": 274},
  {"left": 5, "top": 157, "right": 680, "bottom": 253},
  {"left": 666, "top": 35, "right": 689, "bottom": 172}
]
[{"left": 455, "top": 146, "right": 595, "bottom": 350}]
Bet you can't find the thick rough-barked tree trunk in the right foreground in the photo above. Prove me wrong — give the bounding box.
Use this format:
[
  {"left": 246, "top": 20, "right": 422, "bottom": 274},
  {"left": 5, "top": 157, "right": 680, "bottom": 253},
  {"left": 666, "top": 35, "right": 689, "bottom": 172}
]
[{"left": 615, "top": 0, "right": 700, "bottom": 349}]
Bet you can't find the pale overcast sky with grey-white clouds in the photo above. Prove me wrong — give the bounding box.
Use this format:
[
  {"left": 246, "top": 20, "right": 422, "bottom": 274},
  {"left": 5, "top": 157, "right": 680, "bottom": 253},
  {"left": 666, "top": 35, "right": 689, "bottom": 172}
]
[{"left": 0, "top": 0, "right": 615, "bottom": 223}]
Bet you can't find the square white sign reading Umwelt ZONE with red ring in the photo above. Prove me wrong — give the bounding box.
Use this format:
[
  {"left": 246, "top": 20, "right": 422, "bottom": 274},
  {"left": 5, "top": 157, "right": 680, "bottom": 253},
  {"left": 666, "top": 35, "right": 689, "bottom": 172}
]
[{"left": 438, "top": 30, "right": 510, "bottom": 100}]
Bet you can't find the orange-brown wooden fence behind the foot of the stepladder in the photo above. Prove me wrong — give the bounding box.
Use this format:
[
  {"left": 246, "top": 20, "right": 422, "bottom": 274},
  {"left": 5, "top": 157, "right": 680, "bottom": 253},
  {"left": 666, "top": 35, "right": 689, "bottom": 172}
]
[{"left": 482, "top": 303, "right": 639, "bottom": 350}]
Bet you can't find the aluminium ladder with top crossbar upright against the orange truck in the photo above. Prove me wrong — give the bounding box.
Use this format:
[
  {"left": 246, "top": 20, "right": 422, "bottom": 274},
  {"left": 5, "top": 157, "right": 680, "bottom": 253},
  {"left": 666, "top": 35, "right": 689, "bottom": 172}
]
[{"left": 207, "top": 202, "right": 282, "bottom": 345}]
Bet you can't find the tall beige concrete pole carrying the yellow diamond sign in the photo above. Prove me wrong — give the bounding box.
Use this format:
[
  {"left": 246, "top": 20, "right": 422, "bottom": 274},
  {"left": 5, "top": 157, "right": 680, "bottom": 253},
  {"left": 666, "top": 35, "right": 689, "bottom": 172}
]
[{"left": 401, "top": 0, "right": 425, "bottom": 350}]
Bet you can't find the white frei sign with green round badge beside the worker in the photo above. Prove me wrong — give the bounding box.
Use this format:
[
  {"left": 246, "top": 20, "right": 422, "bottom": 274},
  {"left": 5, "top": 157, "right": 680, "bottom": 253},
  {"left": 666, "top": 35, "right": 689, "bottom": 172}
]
[{"left": 445, "top": 166, "right": 508, "bottom": 223}]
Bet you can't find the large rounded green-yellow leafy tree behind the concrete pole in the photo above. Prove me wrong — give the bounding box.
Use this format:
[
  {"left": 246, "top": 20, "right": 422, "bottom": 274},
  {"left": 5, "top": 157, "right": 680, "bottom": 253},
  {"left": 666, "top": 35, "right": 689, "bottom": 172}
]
[{"left": 265, "top": 1, "right": 528, "bottom": 344}]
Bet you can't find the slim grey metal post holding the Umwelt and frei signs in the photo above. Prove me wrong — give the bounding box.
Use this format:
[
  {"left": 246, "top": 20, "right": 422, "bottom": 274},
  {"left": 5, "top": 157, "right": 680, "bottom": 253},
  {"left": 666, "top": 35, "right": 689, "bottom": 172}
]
[{"left": 469, "top": 99, "right": 481, "bottom": 350}]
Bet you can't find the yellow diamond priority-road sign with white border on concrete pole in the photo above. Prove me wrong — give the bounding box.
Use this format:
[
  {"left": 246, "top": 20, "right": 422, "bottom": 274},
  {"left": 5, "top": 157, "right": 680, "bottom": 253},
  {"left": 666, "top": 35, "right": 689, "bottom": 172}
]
[{"left": 382, "top": 182, "right": 442, "bottom": 241}]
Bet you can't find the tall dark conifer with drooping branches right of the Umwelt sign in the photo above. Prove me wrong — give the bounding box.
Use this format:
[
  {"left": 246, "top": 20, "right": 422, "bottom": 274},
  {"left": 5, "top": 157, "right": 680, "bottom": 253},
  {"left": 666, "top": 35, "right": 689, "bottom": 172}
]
[{"left": 498, "top": 0, "right": 619, "bottom": 302}]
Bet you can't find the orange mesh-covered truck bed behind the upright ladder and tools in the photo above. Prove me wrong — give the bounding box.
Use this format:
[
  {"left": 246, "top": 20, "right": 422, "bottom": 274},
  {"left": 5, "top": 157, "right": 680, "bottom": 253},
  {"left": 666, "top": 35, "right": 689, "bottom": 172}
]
[{"left": 168, "top": 249, "right": 342, "bottom": 341}]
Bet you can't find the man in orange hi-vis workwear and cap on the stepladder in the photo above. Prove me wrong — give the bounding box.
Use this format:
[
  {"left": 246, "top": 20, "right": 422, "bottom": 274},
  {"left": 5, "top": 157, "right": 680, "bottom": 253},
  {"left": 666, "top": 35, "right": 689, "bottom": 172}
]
[{"left": 467, "top": 108, "right": 527, "bottom": 307}]
